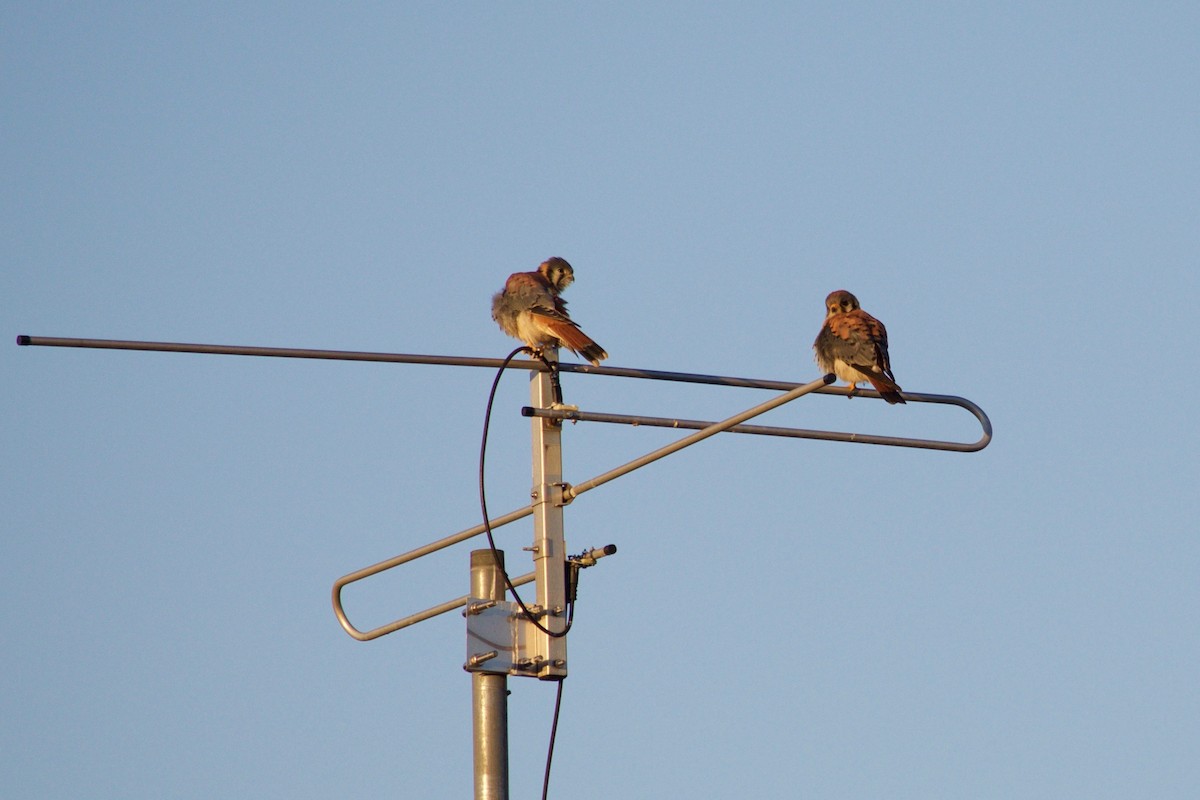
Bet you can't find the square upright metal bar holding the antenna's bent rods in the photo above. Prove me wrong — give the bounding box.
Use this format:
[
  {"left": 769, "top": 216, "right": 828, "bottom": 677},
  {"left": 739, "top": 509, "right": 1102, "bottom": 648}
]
[{"left": 529, "top": 348, "right": 566, "bottom": 680}]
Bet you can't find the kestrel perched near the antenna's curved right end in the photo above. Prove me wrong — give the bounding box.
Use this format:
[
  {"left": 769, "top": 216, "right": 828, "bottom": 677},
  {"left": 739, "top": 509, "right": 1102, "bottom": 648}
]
[{"left": 812, "top": 289, "right": 904, "bottom": 404}]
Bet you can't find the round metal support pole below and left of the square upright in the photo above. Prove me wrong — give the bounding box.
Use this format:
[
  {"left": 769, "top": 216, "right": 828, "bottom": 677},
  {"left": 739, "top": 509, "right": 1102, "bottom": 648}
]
[{"left": 470, "top": 549, "right": 509, "bottom": 800}]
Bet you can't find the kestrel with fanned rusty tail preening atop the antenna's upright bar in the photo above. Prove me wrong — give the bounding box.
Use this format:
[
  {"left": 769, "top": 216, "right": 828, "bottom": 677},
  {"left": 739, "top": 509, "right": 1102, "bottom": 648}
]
[{"left": 492, "top": 257, "right": 608, "bottom": 367}]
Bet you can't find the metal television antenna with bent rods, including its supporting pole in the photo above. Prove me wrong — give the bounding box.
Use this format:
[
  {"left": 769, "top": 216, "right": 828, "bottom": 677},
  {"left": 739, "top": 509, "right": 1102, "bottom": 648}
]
[{"left": 17, "top": 335, "right": 991, "bottom": 800}]
